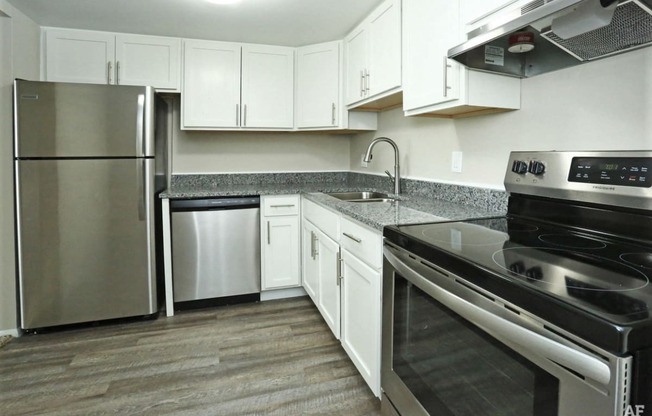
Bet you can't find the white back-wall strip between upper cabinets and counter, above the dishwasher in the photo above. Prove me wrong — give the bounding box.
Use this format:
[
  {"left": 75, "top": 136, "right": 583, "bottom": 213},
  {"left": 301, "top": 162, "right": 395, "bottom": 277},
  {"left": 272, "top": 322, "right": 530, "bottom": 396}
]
[{"left": 172, "top": 100, "right": 350, "bottom": 174}]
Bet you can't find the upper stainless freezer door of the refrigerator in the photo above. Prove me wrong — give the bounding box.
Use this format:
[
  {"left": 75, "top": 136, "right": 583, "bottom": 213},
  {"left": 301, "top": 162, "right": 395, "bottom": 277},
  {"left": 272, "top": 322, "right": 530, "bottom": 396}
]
[{"left": 14, "top": 80, "right": 154, "bottom": 158}]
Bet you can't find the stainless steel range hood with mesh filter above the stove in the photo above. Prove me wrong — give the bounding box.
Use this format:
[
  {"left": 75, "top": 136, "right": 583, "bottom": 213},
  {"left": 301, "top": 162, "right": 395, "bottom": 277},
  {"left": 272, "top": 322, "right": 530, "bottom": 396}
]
[{"left": 448, "top": 0, "right": 652, "bottom": 78}]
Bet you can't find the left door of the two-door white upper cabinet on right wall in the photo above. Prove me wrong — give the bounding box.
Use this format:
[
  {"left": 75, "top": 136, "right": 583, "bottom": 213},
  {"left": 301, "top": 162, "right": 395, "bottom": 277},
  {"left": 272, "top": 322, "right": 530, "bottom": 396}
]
[{"left": 344, "top": 28, "right": 369, "bottom": 104}]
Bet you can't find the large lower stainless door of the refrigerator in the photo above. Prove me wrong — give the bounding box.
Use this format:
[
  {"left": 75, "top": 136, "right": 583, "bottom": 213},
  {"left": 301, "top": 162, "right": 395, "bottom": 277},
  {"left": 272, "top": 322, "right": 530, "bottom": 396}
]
[{"left": 16, "top": 159, "right": 157, "bottom": 329}]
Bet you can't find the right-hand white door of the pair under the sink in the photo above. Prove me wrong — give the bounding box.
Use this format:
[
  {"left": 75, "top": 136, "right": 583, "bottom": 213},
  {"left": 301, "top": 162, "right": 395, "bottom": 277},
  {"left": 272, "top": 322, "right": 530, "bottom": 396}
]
[{"left": 317, "top": 230, "right": 340, "bottom": 339}]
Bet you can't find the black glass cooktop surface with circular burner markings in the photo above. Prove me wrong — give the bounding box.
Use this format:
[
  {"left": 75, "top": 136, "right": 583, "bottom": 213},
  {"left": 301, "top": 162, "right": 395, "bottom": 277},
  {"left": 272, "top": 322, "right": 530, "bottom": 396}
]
[{"left": 388, "top": 216, "right": 652, "bottom": 325}]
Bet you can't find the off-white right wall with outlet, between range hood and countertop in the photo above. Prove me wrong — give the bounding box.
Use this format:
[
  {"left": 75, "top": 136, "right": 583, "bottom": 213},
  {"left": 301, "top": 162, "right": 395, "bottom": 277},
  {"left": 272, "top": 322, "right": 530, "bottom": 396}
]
[{"left": 351, "top": 48, "right": 652, "bottom": 189}]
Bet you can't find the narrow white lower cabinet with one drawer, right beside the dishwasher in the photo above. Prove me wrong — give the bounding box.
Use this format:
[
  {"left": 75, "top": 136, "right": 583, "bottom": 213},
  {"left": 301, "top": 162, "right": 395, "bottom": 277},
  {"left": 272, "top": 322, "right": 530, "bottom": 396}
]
[{"left": 260, "top": 195, "right": 301, "bottom": 290}]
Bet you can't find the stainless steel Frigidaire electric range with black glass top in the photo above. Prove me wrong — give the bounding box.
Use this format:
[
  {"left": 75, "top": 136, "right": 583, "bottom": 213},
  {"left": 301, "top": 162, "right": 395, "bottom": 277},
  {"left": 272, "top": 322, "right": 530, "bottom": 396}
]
[{"left": 383, "top": 151, "right": 652, "bottom": 415}]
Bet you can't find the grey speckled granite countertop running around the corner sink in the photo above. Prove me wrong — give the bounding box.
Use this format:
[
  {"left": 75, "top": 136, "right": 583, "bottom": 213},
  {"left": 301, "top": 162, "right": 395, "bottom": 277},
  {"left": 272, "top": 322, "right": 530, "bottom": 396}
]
[{"left": 161, "top": 177, "right": 505, "bottom": 231}]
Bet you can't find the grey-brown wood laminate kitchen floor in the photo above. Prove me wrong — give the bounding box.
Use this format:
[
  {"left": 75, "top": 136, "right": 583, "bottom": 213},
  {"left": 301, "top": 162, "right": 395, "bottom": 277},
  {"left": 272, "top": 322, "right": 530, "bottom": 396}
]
[{"left": 0, "top": 297, "right": 380, "bottom": 416}]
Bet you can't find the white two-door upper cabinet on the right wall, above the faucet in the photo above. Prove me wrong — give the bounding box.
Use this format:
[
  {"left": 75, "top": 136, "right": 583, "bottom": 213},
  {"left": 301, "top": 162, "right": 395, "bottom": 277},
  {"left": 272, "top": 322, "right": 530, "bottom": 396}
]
[{"left": 344, "top": 0, "right": 401, "bottom": 108}]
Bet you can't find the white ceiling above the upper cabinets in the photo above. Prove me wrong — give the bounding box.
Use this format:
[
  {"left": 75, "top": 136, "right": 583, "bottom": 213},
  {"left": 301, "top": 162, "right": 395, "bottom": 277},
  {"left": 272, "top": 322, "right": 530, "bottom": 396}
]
[{"left": 8, "top": 0, "right": 382, "bottom": 46}]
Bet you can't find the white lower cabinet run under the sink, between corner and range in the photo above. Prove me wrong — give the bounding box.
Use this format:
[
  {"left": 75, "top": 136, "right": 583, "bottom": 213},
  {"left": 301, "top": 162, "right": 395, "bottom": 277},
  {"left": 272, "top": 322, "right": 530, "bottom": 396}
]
[{"left": 302, "top": 199, "right": 382, "bottom": 397}]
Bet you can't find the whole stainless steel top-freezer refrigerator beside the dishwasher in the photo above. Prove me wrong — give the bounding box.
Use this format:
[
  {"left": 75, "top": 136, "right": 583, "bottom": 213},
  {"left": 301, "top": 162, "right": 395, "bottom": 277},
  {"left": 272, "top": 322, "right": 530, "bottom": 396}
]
[{"left": 14, "top": 80, "right": 165, "bottom": 329}]
